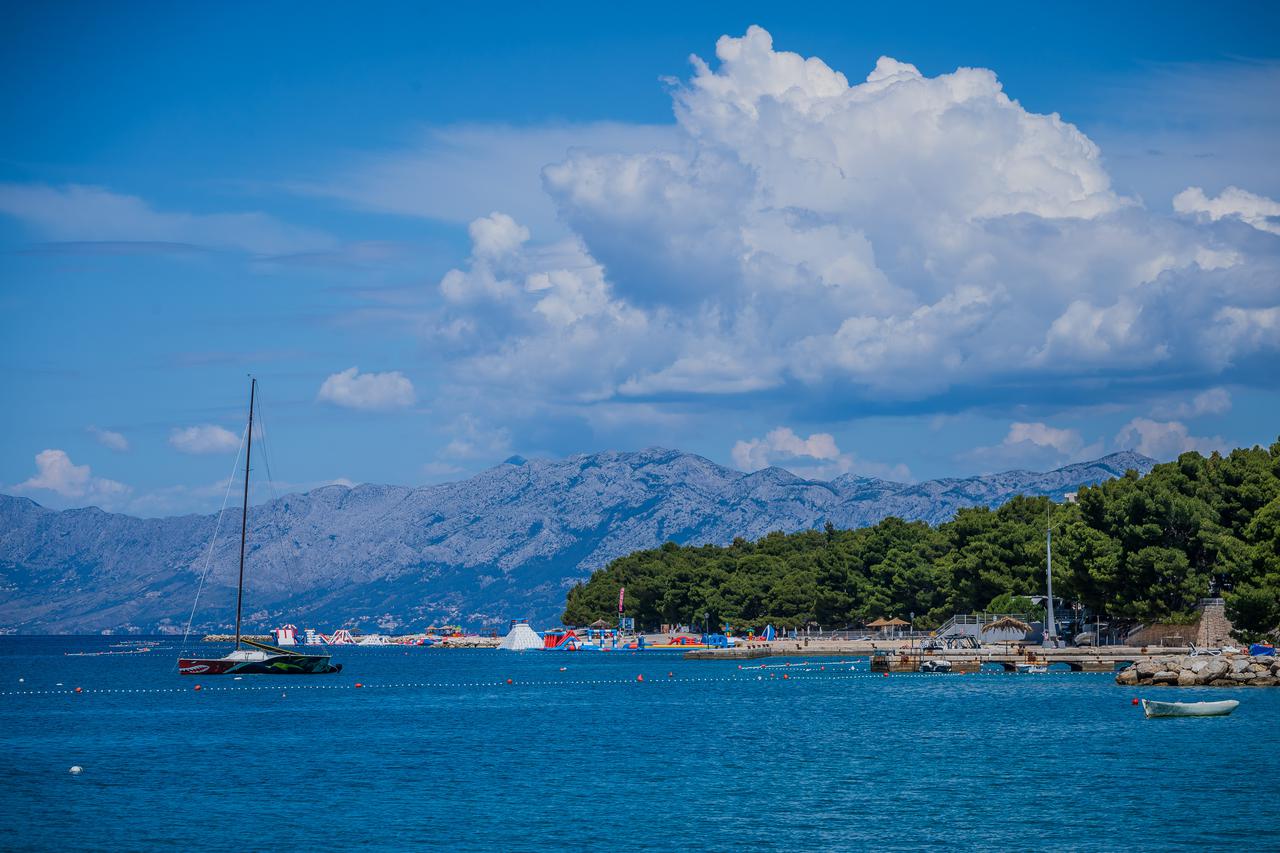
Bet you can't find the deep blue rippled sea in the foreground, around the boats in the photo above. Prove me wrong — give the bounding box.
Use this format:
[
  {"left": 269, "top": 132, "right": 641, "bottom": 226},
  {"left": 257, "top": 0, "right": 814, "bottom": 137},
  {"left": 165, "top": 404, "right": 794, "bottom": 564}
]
[{"left": 0, "top": 637, "right": 1280, "bottom": 853}]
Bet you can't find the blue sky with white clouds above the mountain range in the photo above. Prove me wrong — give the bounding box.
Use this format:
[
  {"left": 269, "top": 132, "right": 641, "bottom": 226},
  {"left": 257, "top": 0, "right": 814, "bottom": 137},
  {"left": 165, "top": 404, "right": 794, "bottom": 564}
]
[{"left": 0, "top": 4, "right": 1280, "bottom": 515}]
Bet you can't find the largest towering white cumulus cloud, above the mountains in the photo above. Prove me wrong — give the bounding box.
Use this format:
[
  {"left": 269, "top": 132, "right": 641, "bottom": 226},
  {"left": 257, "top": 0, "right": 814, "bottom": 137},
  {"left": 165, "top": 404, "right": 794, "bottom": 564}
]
[{"left": 414, "top": 27, "right": 1280, "bottom": 422}]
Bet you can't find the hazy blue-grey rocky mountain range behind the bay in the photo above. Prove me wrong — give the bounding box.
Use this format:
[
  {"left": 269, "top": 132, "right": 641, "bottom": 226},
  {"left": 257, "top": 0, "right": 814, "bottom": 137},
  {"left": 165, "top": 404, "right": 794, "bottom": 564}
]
[{"left": 0, "top": 448, "right": 1155, "bottom": 633}]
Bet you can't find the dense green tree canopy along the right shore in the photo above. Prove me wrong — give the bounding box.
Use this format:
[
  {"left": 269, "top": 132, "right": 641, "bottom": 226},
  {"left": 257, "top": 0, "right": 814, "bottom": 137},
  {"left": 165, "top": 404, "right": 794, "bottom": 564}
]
[{"left": 563, "top": 441, "right": 1280, "bottom": 637}]
